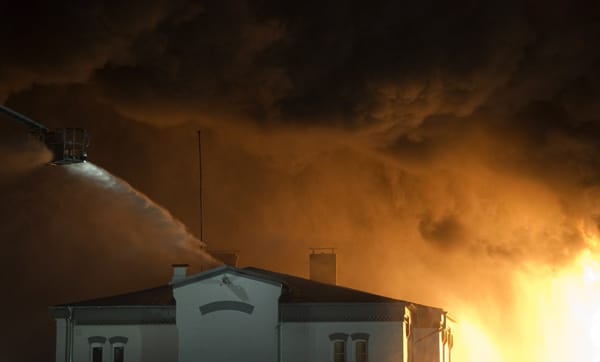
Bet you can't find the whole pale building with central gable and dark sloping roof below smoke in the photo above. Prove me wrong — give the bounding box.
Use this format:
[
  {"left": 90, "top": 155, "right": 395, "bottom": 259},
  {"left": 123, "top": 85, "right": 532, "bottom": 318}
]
[{"left": 50, "top": 266, "right": 452, "bottom": 362}]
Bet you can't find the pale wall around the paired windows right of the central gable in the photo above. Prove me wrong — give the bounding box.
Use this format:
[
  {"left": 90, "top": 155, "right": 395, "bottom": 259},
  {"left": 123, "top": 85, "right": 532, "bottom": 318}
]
[{"left": 281, "top": 322, "right": 405, "bottom": 362}]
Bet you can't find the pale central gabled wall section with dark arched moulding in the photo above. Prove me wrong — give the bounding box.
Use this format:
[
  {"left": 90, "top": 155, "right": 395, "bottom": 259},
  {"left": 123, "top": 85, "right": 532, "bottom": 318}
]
[{"left": 173, "top": 273, "right": 281, "bottom": 362}]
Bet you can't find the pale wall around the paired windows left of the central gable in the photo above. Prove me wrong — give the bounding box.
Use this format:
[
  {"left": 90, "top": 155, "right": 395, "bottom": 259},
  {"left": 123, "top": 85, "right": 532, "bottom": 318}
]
[{"left": 56, "top": 319, "right": 177, "bottom": 362}]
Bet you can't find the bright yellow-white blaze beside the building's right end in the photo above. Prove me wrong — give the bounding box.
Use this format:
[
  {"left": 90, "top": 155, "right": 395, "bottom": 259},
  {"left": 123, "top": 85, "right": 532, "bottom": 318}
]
[{"left": 453, "top": 229, "right": 600, "bottom": 362}]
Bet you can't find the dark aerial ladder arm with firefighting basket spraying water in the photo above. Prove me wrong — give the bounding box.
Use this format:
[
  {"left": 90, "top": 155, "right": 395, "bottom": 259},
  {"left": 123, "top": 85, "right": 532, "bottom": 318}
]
[{"left": 0, "top": 104, "right": 89, "bottom": 165}]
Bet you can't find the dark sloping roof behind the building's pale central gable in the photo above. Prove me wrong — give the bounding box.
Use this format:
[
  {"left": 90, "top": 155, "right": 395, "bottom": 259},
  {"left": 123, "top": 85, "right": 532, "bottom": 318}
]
[{"left": 55, "top": 266, "right": 440, "bottom": 307}]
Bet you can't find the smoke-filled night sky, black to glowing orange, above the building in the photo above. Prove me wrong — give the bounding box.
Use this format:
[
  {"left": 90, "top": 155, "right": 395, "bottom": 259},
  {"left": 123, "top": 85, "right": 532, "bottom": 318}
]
[{"left": 0, "top": 0, "right": 600, "bottom": 362}]
